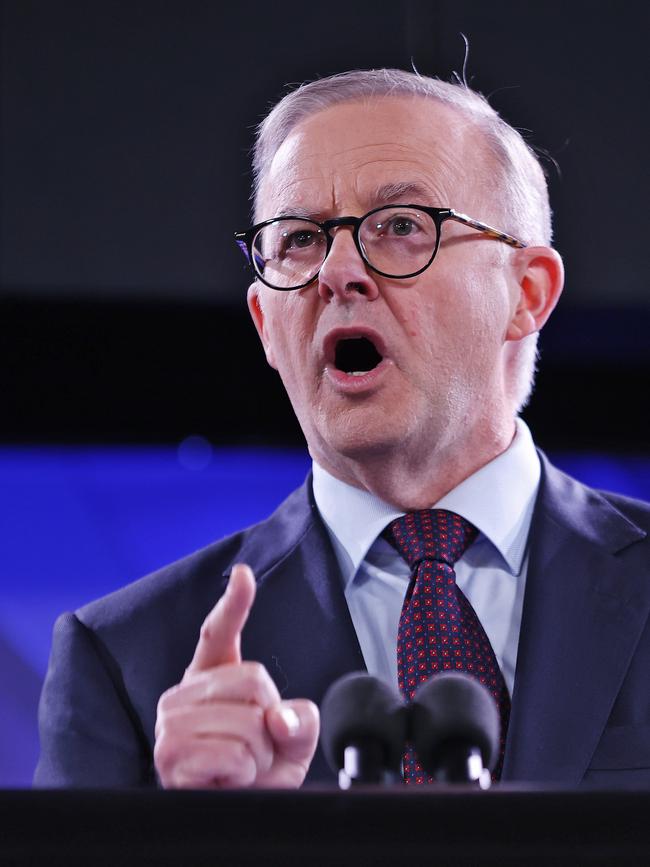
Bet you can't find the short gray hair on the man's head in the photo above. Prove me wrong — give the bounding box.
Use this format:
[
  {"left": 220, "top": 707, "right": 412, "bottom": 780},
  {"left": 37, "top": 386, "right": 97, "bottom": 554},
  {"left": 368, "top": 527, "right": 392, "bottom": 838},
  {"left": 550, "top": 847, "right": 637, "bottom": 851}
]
[{"left": 253, "top": 69, "right": 552, "bottom": 410}]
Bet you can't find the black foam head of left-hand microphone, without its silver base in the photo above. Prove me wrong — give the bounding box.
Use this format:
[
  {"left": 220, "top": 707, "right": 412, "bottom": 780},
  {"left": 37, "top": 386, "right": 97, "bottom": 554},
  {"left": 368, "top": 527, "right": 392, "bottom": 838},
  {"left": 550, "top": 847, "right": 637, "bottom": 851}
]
[{"left": 320, "top": 672, "right": 407, "bottom": 771}]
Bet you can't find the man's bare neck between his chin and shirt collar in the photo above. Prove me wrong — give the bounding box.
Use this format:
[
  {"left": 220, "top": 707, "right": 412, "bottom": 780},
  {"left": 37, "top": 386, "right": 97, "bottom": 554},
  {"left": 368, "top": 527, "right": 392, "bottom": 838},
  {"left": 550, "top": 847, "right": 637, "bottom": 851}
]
[{"left": 312, "top": 419, "right": 515, "bottom": 512}]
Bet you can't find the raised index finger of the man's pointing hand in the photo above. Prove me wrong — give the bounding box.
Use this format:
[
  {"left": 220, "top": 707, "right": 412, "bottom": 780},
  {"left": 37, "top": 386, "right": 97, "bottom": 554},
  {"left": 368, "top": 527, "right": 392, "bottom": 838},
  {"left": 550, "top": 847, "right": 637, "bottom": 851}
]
[{"left": 187, "top": 563, "right": 255, "bottom": 672}]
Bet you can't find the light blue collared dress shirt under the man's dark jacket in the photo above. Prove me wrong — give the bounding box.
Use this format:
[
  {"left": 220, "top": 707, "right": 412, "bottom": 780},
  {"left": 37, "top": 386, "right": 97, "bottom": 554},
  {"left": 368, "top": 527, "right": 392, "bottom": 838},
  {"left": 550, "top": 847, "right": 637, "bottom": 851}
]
[{"left": 313, "top": 419, "right": 541, "bottom": 695}]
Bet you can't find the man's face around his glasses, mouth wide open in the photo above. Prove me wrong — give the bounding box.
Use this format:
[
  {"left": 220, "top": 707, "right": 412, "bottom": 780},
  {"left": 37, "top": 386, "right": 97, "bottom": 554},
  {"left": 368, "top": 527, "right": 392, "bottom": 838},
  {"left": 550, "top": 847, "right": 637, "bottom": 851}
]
[{"left": 249, "top": 97, "right": 518, "bottom": 477}]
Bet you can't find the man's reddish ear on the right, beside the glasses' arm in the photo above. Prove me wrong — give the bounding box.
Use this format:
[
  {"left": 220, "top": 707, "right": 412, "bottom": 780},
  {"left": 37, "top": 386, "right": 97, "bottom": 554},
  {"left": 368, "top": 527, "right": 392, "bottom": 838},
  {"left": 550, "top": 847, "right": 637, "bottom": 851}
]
[{"left": 506, "top": 247, "right": 564, "bottom": 340}]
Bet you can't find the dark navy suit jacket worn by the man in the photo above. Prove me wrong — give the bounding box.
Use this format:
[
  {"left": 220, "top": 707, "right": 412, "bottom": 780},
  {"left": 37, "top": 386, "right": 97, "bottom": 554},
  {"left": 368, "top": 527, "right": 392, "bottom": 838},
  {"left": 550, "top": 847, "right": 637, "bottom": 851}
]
[{"left": 35, "top": 457, "right": 650, "bottom": 786}]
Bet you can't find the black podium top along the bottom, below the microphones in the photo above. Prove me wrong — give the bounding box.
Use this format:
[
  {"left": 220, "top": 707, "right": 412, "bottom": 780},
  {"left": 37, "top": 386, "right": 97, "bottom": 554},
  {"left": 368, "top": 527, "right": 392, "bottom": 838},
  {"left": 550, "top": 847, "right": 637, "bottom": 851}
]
[{"left": 0, "top": 786, "right": 650, "bottom": 867}]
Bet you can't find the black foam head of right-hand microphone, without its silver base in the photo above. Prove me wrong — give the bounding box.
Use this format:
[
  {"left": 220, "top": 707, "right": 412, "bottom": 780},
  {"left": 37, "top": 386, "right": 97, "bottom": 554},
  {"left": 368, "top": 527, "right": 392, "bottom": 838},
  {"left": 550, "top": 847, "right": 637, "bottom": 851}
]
[{"left": 410, "top": 671, "right": 501, "bottom": 774}]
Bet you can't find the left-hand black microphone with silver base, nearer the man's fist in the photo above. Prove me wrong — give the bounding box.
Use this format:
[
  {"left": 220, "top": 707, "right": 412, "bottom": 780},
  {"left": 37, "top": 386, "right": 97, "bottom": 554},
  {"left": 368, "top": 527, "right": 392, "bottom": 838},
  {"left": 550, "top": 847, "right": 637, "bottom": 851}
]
[{"left": 321, "top": 672, "right": 407, "bottom": 789}]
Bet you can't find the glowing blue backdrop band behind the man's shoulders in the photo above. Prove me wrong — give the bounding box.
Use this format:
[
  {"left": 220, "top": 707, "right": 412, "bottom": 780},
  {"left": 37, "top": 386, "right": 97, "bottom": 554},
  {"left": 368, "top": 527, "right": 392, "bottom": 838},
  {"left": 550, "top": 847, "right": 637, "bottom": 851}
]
[{"left": 0, "top": 441, "right": 650, "bottom": 786}]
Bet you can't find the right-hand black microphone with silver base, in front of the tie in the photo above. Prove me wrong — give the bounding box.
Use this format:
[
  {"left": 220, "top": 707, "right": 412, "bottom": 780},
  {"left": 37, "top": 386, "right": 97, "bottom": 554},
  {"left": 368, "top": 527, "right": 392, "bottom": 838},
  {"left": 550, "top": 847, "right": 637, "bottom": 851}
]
[{"left": 410, "top": 671, "right": 501, "bottom": 789}]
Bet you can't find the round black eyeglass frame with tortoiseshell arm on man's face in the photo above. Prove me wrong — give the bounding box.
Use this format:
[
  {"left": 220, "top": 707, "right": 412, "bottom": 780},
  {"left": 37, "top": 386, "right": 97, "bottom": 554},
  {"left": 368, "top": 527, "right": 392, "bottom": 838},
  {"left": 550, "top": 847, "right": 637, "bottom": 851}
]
[{"left": 235, "top": 204, "right": 528, "bottom": 292}]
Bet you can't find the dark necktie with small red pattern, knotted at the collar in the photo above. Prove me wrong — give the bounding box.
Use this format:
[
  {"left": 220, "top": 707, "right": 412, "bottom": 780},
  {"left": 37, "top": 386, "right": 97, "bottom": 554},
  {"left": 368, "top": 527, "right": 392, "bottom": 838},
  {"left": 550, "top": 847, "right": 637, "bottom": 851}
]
[{"left": 383, "top": 509, "right": 510, "bottom": 785}]
